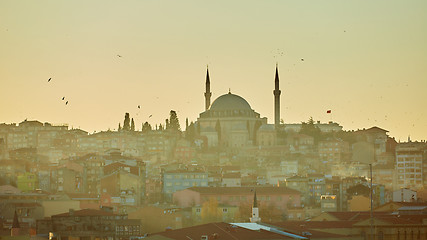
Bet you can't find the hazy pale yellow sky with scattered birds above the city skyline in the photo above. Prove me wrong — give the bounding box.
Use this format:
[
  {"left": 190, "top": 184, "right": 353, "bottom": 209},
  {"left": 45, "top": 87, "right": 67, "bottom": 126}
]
[{"left": 0, "top": 0, "right": 427, "bottom": 140}]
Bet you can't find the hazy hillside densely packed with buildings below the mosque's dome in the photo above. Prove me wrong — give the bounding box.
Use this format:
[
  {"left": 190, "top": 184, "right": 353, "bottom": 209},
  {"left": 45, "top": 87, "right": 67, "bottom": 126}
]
[{"left": 0, "top": 118, "right": 427, "bottom": 239}]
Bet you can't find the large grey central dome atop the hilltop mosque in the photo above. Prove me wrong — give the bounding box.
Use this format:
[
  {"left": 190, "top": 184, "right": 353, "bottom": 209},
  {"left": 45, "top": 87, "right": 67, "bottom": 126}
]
[{"left": 210, "top": 93, "right": 252, "bottom": 111}]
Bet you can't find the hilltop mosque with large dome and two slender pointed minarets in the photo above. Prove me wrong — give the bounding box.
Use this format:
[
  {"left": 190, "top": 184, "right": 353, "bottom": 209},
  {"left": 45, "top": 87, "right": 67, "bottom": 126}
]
[{"left": 197, "top": 65, "right": 281, "bottom": 148}]
